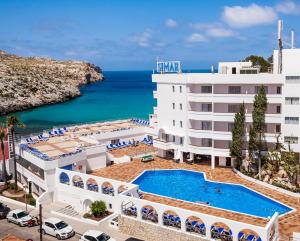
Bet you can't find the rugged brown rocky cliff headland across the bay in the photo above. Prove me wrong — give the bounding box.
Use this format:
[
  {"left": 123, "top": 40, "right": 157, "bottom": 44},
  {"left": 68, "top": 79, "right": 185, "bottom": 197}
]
[{"left": 0, "top": 50, "right": 103, "bottom": 115}]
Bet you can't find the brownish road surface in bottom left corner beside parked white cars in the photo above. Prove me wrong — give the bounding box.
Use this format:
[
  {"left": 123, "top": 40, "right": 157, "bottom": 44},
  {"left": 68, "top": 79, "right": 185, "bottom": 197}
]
[{"left": 0, "top": 219, "right": 80, "bottom": 241}]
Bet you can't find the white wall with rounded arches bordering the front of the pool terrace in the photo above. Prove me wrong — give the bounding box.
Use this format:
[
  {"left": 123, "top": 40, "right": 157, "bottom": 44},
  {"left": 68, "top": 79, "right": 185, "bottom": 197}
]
[{"left": 54, "top": 168, "right": 278, "bottom": 241}]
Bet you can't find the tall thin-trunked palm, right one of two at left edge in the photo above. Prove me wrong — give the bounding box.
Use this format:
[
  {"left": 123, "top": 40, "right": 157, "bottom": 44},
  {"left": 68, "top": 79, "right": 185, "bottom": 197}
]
[{"left": 6, "top": 116, "right": 25, "bottom": 192}]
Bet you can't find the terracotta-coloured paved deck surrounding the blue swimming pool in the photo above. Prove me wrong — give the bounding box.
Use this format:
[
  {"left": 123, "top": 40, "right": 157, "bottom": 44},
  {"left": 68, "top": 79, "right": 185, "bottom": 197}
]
[{"left": 92, "top": 157, "right": 300, "bottom": 240}]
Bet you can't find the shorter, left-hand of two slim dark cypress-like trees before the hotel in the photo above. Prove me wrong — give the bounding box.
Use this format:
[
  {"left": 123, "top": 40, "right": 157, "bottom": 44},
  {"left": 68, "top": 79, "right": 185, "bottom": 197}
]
[{"left": 230, "top": 103, "right": 245, "bottom": 169}]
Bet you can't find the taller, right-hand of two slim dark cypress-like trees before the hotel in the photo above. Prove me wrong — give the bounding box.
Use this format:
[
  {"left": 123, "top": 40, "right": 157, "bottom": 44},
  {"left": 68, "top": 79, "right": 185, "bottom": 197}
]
[{"left": 249, "top": 86, "right": 268, "bottom": 179}]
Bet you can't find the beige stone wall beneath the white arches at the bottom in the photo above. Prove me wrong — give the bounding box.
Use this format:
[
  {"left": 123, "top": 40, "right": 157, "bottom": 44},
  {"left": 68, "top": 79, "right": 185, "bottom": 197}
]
[{"left": 119, "top": 216, "right": 207, "bottom": 241}]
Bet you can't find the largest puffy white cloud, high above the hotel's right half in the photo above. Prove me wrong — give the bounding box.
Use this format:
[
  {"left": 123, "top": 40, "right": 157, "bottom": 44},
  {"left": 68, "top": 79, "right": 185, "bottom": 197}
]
[{"left": 222, "top": 4, "right": 277, "bottom": 28}]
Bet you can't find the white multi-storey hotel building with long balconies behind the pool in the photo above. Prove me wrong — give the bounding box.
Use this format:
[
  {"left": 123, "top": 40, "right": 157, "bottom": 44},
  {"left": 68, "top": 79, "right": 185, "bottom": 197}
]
[{"left": 151, "top": 48, "right": 300, "bottom": 168}]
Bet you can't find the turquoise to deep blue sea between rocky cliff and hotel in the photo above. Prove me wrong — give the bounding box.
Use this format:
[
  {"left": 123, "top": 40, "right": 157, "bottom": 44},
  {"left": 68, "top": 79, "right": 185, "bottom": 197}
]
[{"left": 11, "top": 71, "right": 156, "bottom": 133}]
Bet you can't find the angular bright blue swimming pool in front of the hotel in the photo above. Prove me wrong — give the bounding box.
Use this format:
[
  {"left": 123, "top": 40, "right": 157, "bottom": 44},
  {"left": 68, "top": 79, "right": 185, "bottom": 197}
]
[{"left": 133, "top": 170, "right": 292, "bottom": 218}]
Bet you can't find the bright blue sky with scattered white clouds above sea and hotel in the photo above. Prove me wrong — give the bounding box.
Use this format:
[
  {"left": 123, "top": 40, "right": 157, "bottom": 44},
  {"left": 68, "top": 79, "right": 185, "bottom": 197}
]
[{"left": 0, "top": 0, "right": 300, "bottom": 70}]
